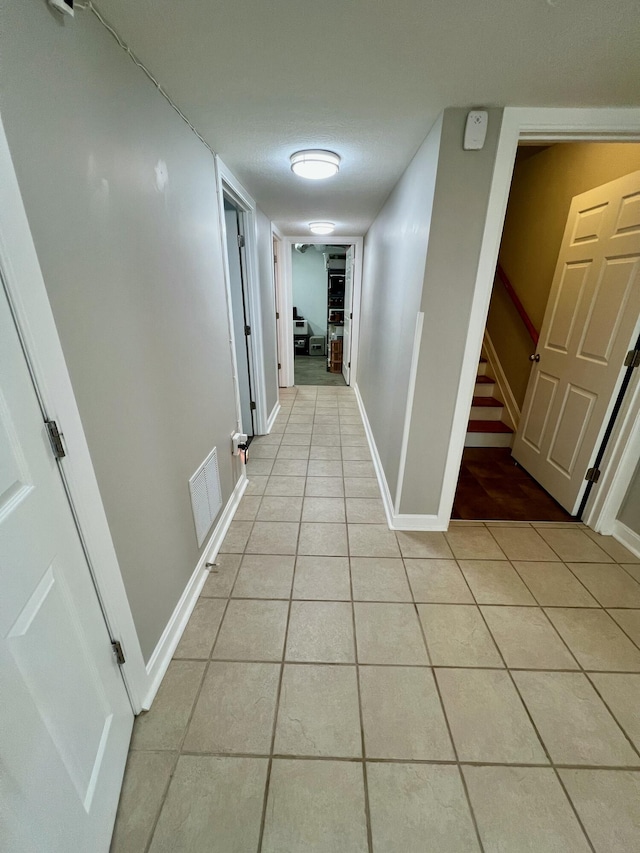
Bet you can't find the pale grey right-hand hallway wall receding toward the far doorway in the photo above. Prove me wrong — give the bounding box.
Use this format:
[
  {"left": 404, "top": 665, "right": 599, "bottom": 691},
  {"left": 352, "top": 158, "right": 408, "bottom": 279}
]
[{"left": 357, "top": 118, "right": 442, "bottom": 496}]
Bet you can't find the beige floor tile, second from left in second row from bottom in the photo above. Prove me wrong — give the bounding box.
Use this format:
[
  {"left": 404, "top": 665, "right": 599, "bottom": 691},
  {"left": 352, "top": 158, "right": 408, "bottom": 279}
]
[{"left": 184, "top": 661, "right": 280, "bottom": 755}]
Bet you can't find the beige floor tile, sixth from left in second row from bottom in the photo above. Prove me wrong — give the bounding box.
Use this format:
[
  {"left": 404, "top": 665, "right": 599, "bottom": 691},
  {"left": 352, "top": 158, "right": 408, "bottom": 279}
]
[{"left": 513, "top": 672, "right": 640, "bottom": 766}]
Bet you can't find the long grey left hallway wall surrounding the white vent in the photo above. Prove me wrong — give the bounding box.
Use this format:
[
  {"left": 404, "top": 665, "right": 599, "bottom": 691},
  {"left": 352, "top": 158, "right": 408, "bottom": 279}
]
[{"left": 0, "top": 0, "right": 240, "bottom": 659}]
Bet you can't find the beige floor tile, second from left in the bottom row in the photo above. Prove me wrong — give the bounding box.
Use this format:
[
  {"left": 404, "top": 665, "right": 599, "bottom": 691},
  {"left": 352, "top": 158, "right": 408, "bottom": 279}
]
[{"left": 149, "top": 755, "right": 269, "bottom": 853}]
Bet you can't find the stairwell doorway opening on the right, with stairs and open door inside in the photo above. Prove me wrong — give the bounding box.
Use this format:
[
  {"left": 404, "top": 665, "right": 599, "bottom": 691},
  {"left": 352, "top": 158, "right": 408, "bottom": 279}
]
[{"left": 452, "top": 142, "right": 640, "bottom": 522}]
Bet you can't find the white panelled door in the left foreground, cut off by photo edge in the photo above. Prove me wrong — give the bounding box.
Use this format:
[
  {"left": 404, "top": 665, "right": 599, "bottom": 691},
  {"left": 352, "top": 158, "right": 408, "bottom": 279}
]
[{"left": 0, "top": 281, "right": 133, "bottom": 853}]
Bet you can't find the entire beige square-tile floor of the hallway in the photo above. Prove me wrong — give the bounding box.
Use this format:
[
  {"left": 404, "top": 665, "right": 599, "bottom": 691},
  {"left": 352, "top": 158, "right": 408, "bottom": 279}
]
[{"left": 112, "top": 387, "right": 640, "bottom": 853}]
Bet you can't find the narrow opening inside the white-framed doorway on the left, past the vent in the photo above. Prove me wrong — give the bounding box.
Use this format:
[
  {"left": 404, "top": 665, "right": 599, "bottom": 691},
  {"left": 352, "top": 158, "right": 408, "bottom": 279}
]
[{"left": 224, "top": 194, "right": 256, "bottom": 441}]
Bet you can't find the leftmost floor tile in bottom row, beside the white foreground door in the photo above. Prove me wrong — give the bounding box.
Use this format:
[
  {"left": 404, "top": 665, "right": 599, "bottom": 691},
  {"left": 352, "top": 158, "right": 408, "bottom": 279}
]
[{"left": 109, "top": 752, "right": 176, "bottom": 853}]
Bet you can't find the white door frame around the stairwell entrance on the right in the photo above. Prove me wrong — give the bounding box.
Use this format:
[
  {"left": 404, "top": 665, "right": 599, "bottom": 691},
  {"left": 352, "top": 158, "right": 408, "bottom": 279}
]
[{"left": 438, "top": 107, "right": 640, "bottom": 532}]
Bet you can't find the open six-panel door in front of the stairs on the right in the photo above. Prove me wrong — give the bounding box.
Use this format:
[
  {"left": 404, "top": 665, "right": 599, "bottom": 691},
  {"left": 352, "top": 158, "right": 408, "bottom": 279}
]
[{"left": 513, "top": 172, "right": 640, "bottom": 513}]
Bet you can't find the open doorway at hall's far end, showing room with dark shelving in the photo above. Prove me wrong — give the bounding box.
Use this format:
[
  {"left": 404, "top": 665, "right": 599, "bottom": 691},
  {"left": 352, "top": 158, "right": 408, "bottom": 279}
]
[{"left": 291, "top": 243, "right": 353, "bottom": 387}]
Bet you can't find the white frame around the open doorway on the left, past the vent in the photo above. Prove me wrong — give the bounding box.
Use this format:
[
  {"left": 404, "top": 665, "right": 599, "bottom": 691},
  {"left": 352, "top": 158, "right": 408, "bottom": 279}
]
[{"left": 215, "top": 155, "right": 269, "bottom": 435}]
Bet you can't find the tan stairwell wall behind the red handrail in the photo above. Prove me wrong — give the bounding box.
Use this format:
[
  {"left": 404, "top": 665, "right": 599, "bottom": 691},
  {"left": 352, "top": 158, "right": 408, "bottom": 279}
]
[{"left": 487, "top": 142, "right": 640, "bottom": 405}]
